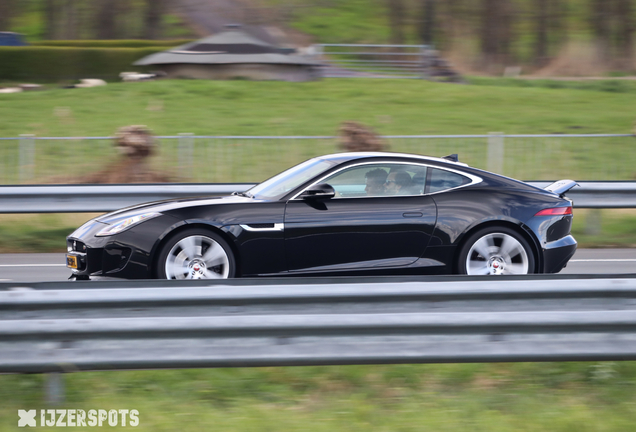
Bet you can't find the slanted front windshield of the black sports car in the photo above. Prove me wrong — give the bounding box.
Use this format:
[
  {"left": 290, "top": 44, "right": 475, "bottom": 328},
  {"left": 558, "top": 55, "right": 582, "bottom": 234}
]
[{"left": 247, "top": 159, "right": 336, "bottom": 200}]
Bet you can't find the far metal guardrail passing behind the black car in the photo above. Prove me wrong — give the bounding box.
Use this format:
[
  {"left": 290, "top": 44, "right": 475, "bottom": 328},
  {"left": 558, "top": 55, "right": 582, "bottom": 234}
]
[{"left": 0, "top": 182, "right": 636, "bottom": 213}]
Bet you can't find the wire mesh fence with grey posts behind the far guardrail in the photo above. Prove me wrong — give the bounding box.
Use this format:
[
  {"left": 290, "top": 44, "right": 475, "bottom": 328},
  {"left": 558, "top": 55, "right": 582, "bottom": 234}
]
[{"left": 0, "top": 133, "right": 636, "bottom": 184}]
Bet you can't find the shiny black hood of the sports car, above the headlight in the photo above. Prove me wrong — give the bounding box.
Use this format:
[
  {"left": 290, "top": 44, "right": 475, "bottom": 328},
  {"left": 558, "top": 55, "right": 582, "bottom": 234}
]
[{"left": 94, "top": 195, "right": 258, "bottom": 223}]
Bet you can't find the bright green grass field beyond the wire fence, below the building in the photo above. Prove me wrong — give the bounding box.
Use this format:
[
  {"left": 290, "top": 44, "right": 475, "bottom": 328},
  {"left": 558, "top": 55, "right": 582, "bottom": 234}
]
[{"left": 0, "top": 79, "right": 636, "bottom": 137}]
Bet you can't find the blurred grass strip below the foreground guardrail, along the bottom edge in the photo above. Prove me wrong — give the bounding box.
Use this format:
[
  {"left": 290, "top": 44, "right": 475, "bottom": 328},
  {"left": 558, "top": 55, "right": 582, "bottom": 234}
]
[{"left": 0, "top": 362, "right": 636, "bottom": 432}]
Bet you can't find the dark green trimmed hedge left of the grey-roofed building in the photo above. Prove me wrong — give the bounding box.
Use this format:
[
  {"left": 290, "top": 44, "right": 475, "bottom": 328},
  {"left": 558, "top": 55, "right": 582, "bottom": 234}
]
[{"left": 0, "top": 46, "right": 165, "bottom": 82}]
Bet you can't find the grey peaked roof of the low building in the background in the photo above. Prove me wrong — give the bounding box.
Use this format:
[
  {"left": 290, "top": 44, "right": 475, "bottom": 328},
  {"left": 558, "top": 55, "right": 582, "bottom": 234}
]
[{"left": 133, "top": 30, "right": 320, "bottom": 66}]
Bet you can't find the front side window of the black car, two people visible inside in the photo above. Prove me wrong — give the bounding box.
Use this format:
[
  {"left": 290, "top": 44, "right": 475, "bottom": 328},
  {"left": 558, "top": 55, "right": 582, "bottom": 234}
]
[{"left": 321, "top": 163, "right": 427, "bottom": 198}]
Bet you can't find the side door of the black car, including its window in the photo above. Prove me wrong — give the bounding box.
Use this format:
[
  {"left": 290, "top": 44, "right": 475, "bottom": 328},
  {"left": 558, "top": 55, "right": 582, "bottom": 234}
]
[{"left": 285, "top": 162, "right": 437, "bottom": 272}]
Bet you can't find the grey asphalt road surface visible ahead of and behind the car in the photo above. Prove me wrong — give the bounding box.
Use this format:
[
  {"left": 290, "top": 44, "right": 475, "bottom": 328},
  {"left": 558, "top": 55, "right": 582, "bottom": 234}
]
[{"left": 0, "top": 249, "right": 636, "bottom": 282}]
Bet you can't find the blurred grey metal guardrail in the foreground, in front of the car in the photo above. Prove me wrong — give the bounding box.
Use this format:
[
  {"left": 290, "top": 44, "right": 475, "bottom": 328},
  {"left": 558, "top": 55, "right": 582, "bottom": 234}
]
[{"left": 0, "top": 275, "right": 636, "bottom": 373}]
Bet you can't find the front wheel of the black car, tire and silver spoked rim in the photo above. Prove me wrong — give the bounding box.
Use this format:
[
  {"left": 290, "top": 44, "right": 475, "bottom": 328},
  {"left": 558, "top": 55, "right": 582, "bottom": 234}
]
[{"left": 156, "top": 228, "right": 236, "bottom": 279}]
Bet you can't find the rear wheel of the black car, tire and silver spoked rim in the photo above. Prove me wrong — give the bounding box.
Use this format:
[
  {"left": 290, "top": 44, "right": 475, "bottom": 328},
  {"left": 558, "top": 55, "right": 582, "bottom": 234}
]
[{"left": 457, "top": 227, "right": 535, "bottom": 275}]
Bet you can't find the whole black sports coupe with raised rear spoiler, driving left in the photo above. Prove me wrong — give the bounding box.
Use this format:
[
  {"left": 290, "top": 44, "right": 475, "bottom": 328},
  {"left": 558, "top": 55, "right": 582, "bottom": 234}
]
[{"left": 67, "top": 153, "right": 576, "bottom": 279}]
